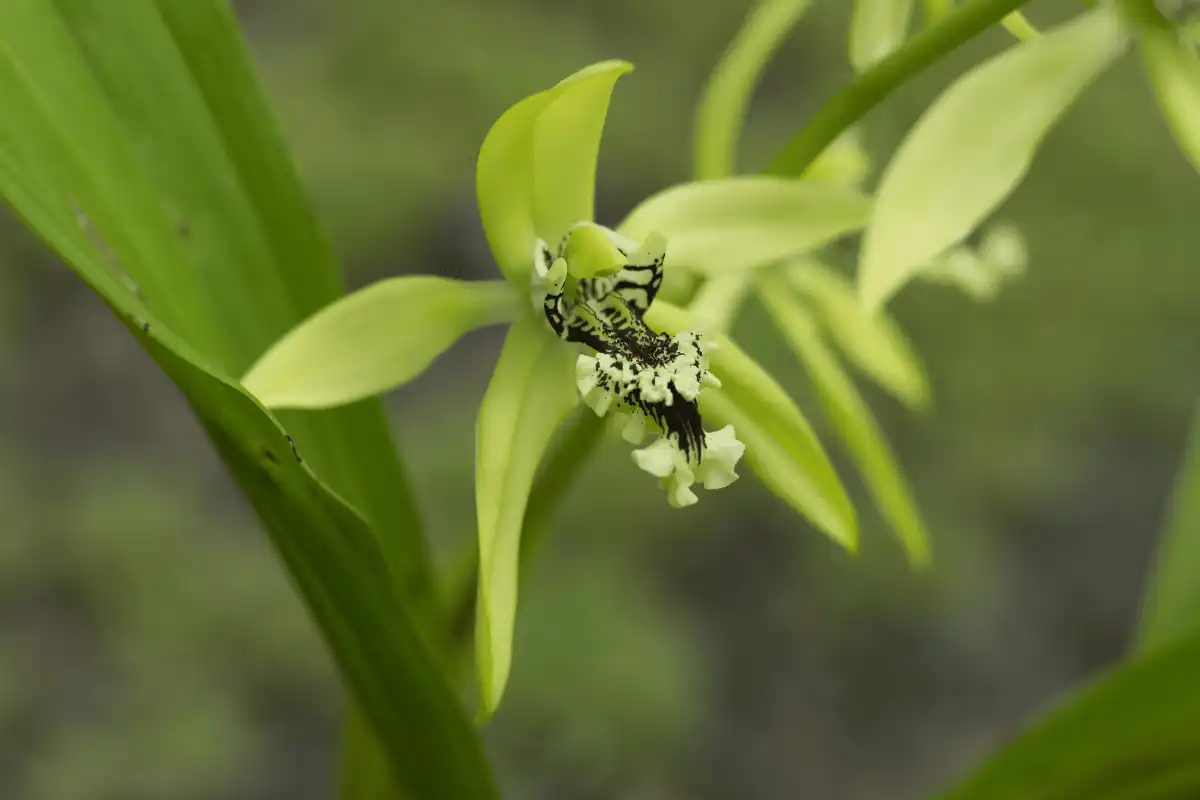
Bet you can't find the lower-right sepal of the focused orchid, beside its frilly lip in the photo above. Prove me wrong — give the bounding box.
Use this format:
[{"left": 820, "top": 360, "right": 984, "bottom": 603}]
[{"left": 646, "top": 300, "right": 858, "bottom": 551}]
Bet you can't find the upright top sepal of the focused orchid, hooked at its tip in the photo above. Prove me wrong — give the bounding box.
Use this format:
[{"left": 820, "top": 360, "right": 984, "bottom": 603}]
[{"left": 475, "top": 61, "right": 634, "bottom": 285}]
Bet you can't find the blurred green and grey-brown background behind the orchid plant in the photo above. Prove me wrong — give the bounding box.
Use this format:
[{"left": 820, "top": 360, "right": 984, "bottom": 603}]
[{"left": 0, "top": 0, "right": 1200, "bottom": 800}]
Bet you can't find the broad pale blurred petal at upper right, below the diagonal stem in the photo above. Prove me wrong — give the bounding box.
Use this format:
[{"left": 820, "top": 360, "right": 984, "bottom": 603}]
[{"left": 859, "top": 8, "right": 1127, "bottom": 308}]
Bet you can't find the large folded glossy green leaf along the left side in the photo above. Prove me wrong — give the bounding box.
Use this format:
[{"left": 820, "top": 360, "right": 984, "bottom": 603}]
[{"left": 0, "top": 0, "right": 493, "bottom": 796}]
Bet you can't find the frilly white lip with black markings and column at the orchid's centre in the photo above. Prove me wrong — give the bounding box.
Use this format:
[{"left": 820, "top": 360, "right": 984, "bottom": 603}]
[{"left": 534, "top": 223, "right": 744, "bottom": 507}]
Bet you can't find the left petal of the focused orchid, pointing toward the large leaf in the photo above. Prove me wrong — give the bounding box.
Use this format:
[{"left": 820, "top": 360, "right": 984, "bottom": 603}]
[{"left": 242, "top": 275, "right": 517, "bottom": 408}]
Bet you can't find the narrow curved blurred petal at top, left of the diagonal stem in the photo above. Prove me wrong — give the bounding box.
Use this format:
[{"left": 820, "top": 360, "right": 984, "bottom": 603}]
[{"left": 692, "top": 0, "right": 812, "bottom": 180}]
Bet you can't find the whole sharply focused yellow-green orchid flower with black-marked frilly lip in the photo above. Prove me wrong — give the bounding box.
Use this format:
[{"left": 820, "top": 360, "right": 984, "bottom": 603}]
[{"left": 244, "top": 61, "right": 870, "bottom": 717}]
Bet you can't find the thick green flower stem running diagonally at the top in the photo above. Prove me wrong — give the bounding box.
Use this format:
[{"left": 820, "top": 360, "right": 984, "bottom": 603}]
[{"left": 766, "top": 0, "right": 1027, "bottom": 175}]
